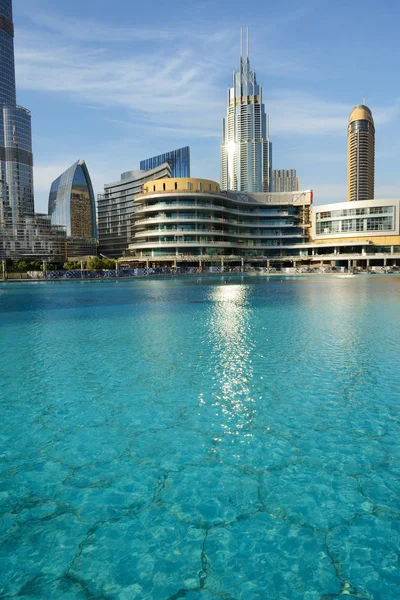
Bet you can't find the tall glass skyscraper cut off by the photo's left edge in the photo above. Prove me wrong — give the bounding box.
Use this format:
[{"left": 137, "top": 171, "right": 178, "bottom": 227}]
[{"left": 0, "top": 0, "right": 34, "bottom": 228}]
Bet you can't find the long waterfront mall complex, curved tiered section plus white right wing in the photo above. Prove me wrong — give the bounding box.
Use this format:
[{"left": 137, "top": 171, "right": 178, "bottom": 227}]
[{"left": 121, "top": 178, "right": 400, "bottom": 268}]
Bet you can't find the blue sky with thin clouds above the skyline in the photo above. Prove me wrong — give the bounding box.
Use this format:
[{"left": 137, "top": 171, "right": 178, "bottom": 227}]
[{"left": 14, "top": 0, "right": 400, "bottom": 211}]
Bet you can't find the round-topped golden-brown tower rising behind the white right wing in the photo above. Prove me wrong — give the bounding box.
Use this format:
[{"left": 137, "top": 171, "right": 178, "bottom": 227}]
[{"left": 347, "top": 104, "right": 375, "bottom": 202}]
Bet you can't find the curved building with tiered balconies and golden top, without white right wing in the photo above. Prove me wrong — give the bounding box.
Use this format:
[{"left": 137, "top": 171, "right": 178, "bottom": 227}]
[{"left": 129, "top": 178, "right": 312, "bottom": 260}]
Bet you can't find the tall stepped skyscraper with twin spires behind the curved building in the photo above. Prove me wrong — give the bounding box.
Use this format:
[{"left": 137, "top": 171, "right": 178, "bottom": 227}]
[{"left": 221, "top": 32, "right": 272, "bottom": 193}]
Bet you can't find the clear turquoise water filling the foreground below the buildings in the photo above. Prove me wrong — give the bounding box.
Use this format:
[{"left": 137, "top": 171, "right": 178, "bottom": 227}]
[{"left": 0, "top": 276, "right": 400, "bottom": 600}]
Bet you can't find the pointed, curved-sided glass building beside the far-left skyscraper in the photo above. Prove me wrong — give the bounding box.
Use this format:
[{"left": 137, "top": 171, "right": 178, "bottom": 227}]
[{"left": 49, "top": 160, "right": 97, "bottom": 257}]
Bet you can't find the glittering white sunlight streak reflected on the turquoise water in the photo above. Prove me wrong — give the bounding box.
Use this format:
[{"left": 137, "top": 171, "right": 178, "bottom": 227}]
[{"left": 208, "top": 285, "right": 254, "bottom": 436}]
